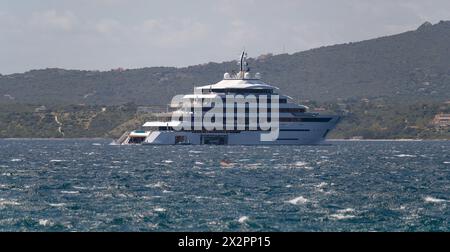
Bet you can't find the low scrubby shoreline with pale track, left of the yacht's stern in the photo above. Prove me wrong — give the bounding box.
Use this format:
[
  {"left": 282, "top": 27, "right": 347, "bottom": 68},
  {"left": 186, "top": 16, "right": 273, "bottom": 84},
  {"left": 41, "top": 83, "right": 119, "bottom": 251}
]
[{"left": 0, "top": 104, "right": 136, "bottom": 138}]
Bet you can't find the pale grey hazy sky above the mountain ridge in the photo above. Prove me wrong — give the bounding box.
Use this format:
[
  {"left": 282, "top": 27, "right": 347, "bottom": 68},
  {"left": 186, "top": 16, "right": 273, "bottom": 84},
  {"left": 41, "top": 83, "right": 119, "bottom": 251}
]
[{"left": 0, "top": 0, "right": 450, "bottom": 74}]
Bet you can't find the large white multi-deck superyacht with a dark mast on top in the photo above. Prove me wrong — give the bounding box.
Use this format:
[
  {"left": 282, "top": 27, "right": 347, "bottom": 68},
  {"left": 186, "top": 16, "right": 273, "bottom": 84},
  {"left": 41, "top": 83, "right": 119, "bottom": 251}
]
[{"left": 119, "top": 52, "right": 339, "bottom": 145}]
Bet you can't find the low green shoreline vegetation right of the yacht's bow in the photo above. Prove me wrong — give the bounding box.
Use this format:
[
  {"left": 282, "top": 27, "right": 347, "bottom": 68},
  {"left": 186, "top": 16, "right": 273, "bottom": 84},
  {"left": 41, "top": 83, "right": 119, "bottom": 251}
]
[{"left": 312, "top": 98, "right": 450, "bottom": 139}]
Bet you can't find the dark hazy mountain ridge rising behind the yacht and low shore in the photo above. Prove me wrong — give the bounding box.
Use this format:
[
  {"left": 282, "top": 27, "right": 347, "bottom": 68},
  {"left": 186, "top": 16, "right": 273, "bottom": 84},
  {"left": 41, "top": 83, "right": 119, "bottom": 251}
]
[{"left": 0, "top": 22, "right": 450, "bottom": 105}]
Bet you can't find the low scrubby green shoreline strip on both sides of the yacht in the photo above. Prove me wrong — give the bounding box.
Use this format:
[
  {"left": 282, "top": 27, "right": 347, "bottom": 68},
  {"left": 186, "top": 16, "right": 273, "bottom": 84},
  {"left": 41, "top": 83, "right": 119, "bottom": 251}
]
[{"left": 0, "top": 98, "right": 450, "bottom": 139}]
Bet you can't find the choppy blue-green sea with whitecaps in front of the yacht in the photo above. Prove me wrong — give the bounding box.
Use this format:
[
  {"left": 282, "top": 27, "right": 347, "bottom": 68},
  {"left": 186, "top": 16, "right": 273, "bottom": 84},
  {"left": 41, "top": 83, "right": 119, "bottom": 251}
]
[{"left": 0, "top": 140, "right": 450, "bottom": 231}]
